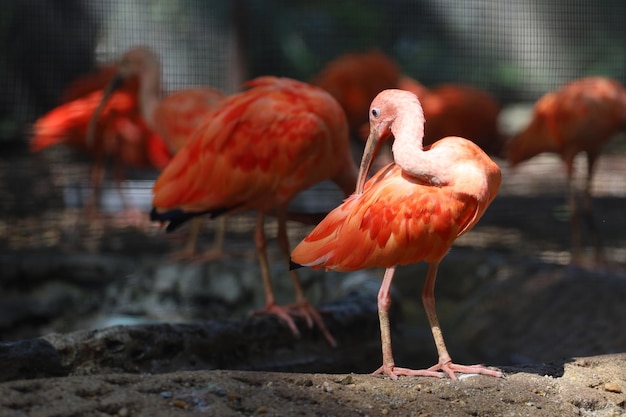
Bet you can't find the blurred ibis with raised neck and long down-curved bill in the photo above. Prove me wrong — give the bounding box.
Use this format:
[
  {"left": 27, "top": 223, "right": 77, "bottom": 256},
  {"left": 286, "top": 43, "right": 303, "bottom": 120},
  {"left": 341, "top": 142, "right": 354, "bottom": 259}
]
[{"left": 93, "top": 46, "right": 225, "bottom": 261}]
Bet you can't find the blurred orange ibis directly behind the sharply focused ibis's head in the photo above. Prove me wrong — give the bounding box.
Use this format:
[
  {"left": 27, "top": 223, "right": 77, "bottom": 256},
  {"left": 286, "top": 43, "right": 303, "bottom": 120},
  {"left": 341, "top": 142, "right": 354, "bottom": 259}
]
[{"left": 311, "top": 49, "right": 400, "bottom": 135}]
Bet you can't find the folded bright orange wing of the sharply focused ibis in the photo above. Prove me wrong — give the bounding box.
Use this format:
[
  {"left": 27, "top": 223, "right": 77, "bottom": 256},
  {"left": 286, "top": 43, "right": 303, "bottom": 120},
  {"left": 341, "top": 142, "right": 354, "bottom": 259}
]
[{"left": 291, "top": 164, "right": 479, "bottom": 271}]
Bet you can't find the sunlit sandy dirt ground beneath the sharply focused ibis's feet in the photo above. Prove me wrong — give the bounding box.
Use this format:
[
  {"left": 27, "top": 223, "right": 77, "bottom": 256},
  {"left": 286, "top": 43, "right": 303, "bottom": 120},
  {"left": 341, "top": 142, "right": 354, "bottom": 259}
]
[{"left": 0, "top": 354, "right": 626, "bottom": 417}]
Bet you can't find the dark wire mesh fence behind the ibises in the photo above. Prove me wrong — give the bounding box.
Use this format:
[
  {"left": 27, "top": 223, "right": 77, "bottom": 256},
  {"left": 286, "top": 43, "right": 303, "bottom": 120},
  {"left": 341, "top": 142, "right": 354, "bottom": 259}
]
[{"left": 0, "top": 0, "right": 626, "bottom": 260}]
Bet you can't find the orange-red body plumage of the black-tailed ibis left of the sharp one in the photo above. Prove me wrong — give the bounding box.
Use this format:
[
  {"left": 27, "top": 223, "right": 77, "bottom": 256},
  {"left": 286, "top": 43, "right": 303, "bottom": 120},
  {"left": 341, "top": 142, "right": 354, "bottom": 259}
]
[{"left": 153, "top": 77, "right": 341, "bottom": 211}]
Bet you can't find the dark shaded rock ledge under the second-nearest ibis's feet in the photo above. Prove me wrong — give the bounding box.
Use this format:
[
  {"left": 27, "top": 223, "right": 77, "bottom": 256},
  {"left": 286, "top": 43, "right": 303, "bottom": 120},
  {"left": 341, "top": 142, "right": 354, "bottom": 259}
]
[{"left": 0, "top": 295, "right": 380, "bottom": 381}]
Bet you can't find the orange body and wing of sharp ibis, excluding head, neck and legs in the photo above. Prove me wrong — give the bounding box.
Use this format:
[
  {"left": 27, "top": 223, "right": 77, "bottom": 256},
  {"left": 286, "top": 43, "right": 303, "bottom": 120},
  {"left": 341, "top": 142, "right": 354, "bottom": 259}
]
[{"left": 291, "top": 137, "right": 501, "bottom": 271}]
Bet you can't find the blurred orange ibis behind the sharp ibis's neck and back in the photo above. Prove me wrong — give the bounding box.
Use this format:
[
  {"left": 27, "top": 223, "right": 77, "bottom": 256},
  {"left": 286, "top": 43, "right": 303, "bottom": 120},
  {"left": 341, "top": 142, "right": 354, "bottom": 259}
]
[{"left": 399, "top": 76, "right": 503, "bottom": 154}]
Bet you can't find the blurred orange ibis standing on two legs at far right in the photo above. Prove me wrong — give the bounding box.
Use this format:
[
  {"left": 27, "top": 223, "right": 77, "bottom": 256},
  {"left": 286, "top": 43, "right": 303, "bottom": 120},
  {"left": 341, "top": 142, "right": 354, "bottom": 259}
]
[{"left": 507, "top": 77, "right": 626, "bottom": 263}]
